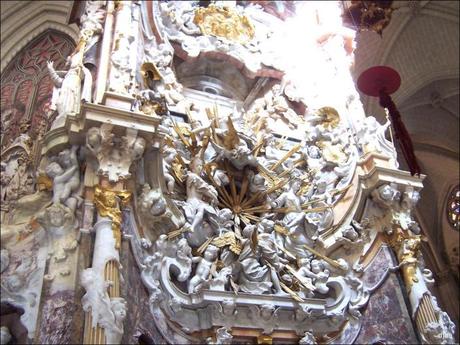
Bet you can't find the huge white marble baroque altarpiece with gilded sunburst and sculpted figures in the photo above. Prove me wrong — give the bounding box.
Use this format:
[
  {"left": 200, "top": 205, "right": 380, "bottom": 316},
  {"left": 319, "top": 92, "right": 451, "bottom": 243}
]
[{"left": 1, "top": 1, "right": 455, "bottom": 344}]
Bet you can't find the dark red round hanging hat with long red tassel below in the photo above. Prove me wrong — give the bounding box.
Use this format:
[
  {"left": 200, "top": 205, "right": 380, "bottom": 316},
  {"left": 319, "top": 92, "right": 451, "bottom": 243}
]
[{"left": 358, "top": 66, "right": 420, "bottom": 176}]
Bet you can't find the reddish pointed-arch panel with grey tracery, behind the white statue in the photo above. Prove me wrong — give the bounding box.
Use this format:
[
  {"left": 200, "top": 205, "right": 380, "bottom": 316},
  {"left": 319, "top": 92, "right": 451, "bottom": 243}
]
[{"left": 0, "top": 30, "right": 75, "bottom": 147}]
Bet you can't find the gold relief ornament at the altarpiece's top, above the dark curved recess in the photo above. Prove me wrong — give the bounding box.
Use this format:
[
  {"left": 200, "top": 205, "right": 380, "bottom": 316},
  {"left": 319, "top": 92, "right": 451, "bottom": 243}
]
[{"left": 193, "top": 4, "right": 254, "bottom": 43}]
